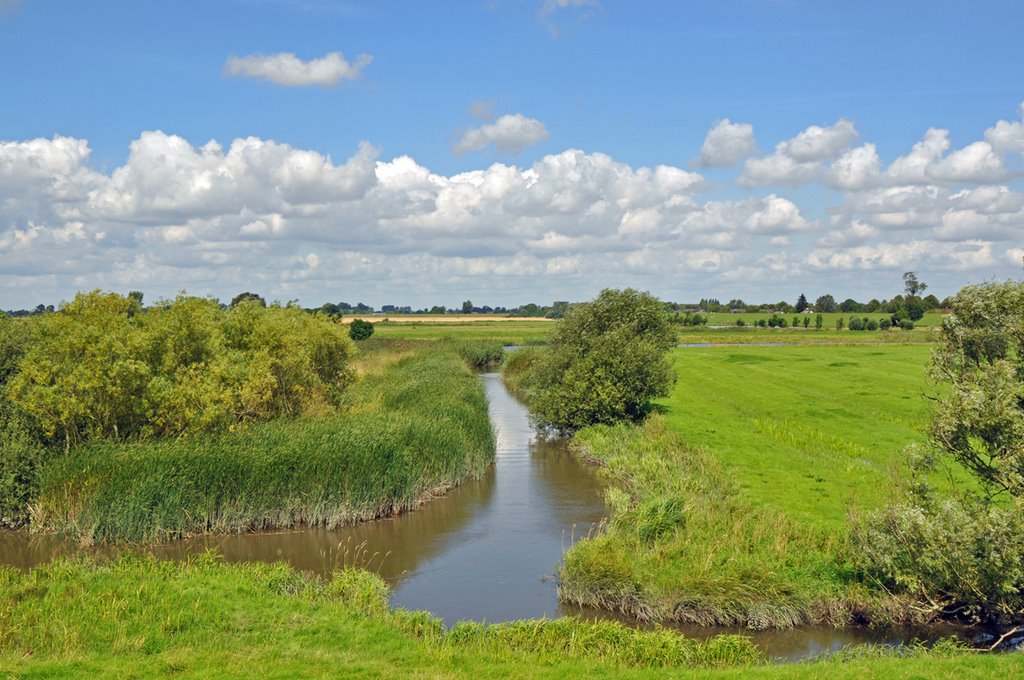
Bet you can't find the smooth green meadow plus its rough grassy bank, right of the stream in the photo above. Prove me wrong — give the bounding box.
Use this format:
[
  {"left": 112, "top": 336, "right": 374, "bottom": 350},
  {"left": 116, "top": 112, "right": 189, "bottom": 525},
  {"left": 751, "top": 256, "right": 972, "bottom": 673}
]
[{"left": 557, "top": 346, "right": 970, "bottom": 628}]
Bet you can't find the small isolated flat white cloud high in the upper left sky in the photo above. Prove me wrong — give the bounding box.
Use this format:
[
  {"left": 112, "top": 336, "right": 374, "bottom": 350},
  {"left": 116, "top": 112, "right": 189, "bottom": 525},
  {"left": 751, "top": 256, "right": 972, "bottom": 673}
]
[{"left": 224, "top": 52, "right": 374, "bottom": 87}]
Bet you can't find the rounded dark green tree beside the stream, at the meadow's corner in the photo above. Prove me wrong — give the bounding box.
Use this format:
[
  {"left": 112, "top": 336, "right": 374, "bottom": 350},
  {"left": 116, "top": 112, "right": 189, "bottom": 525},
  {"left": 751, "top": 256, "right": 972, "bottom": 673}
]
[{"left": 528, "top": 289, "right": 675, "bottom": 431}]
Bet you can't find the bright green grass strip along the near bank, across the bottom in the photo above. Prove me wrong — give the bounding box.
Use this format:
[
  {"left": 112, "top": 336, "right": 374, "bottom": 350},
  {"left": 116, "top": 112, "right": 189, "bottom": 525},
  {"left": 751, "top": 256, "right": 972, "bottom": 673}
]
[{"left": 0, "top": 555, "right": 1024, "bottom": 679}]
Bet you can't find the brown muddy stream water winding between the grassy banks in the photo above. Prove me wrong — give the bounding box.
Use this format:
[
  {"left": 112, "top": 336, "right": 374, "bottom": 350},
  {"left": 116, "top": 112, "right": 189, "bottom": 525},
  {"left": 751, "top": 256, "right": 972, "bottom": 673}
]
[{"left": 0, "top": 373, "right": 974, "bottom": 661}]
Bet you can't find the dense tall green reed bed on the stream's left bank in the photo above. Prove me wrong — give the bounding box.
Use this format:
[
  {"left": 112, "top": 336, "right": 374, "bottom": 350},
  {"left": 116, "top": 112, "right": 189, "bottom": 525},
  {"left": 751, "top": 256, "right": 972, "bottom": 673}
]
[{"left": 33, "top": 345, "right": 495, "bottom": 543}]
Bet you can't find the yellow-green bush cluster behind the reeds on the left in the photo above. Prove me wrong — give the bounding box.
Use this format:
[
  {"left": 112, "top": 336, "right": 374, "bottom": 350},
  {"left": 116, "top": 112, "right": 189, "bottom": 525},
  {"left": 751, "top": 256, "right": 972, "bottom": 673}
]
[{"left": 6, "top": 291, "right": 353, "bottom": 448}]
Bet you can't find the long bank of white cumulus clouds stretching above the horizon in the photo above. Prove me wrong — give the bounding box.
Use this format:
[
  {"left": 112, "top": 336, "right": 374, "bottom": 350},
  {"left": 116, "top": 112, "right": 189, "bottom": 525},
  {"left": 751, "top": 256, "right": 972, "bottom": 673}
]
[{"left": 6, "top": 101, "right": 1024, "bottom": 306}]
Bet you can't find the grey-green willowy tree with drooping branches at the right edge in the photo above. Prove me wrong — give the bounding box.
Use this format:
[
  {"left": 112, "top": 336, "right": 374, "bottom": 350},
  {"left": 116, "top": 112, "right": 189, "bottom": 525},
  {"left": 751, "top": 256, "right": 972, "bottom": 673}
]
[{"left": 854, "top": 282, "right": 1024, "bottom": 622}]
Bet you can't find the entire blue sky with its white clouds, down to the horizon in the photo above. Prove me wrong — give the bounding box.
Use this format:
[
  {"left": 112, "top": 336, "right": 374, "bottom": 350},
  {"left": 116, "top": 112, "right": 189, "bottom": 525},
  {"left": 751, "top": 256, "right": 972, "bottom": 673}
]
[{"left": 0, "top": 0, "right": 1024, "bottom": 307}]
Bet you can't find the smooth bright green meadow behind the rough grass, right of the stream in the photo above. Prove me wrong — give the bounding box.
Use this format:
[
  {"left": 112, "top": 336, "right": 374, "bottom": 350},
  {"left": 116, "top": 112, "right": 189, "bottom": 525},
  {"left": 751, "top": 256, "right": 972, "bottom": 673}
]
[{"left": 662, "top": 346, "right": 946, "bottom": 528}]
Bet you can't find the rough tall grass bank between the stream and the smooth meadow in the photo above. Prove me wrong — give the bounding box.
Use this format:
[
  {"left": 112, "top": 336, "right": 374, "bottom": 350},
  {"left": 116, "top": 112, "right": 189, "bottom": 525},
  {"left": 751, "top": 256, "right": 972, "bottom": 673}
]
[{"left": 559, "top": 415, "right": 910, "bottom": 629}]
